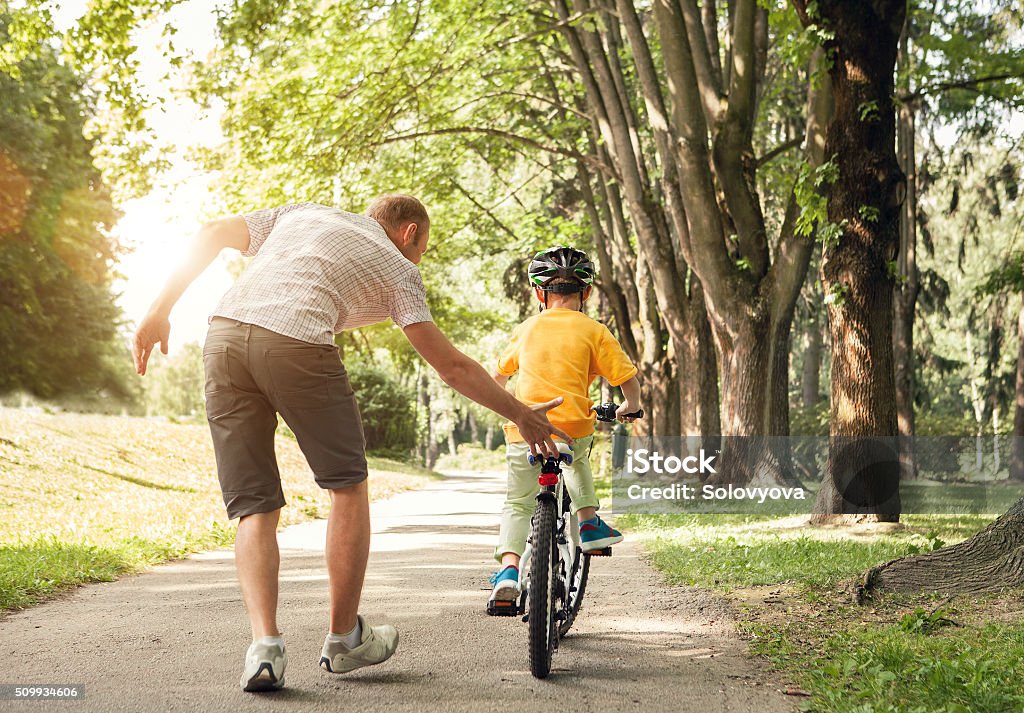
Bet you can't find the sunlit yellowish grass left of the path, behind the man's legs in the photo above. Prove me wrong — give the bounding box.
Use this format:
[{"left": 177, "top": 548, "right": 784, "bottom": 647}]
[{"left": 0, "top": 408, "right": 434, "bottom": 611}]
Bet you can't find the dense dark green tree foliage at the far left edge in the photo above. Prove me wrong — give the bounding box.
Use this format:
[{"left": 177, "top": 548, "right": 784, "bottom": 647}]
[{"left": 0, "top": 14, "right": 132, "bottom": 400}]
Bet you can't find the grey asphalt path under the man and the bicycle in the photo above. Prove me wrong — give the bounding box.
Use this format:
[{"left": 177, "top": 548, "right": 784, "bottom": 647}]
[{"left": 0, "top": 472, "right": 795, "bottom": 713}]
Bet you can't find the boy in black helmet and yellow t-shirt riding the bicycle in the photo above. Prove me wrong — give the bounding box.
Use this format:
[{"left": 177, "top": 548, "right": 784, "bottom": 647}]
[{"left": 490, "top": 247, "right": 640, "bottom": 600}]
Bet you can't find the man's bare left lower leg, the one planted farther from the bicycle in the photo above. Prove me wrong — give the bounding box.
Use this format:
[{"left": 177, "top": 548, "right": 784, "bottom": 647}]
[{"left": 234, "top": 508, "right": 281, "bottom": 641}]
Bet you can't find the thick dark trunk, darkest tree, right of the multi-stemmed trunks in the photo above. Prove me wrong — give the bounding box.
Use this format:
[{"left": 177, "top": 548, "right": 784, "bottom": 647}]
[{"left": 795, "top": 0, "right": 906, "bottom": 521}]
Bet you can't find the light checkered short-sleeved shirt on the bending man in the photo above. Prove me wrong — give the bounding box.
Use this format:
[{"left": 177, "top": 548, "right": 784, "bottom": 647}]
[{"left": 211, "top": 203, "right": 432, "bottom": 344}]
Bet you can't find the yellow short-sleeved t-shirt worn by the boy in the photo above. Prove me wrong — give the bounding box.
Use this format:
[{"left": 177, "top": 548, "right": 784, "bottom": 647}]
[{"left": 498, "top": 307, "right": 637, "bottom": 443}]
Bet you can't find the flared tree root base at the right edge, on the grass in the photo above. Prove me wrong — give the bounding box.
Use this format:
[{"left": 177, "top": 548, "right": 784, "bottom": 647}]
[{"left": 856, "top": 498, "right": 1024, "bottom": 601}]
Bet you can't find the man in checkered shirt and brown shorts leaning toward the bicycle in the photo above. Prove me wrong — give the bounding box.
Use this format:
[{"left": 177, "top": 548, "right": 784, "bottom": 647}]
[{"left": 133, "top": 195, "right": 569, "bottom": 690}]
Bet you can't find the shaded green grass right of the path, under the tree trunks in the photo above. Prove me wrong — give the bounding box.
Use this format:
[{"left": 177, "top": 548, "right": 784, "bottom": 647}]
[{"left": 616, "top": 514, "right": 1024, "bottom": 713}]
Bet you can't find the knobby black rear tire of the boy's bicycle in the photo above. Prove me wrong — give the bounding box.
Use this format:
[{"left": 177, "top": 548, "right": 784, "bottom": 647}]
[{"left": 527, "top": 500, "right": 558, "bottom": 678}]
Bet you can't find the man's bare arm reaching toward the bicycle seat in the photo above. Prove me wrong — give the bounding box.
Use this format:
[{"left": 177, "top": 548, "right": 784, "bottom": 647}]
[{"left": 404, "top": 322, "right": 572, "bottom": 455}]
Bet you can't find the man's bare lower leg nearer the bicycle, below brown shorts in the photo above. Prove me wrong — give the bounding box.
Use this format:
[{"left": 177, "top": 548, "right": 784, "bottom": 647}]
[{"left": 325, "top": 480, "right": 370, "bottom": 634}]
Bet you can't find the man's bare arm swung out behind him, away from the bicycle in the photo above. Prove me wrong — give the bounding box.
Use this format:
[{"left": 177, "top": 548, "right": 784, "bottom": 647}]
[{"left": 132, "top": 217, "right": 249, "bottom": 374}]
